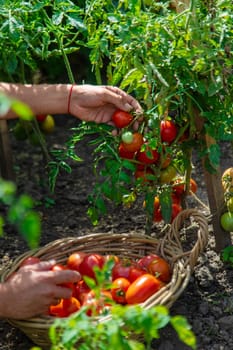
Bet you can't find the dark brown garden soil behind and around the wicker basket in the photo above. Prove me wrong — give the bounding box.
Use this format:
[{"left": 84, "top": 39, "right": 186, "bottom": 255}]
[{"left": 0, "top": 116, "right": 233, "bottom": 350}]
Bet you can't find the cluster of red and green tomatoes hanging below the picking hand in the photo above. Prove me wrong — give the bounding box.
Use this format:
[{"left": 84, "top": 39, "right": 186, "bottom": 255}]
[{"left": 112, "top": 110, "right": 197, "bottom": 222}]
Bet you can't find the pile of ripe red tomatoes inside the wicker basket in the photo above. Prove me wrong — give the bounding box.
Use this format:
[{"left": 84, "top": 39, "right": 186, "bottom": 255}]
[{"left": 20, "top": 251, "right": 171, "bottom": 317}]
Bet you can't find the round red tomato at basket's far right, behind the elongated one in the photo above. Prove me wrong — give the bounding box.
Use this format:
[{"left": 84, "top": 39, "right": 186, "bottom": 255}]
[{"left": 147, "top": 257, "right": 171, "bottom": 283}]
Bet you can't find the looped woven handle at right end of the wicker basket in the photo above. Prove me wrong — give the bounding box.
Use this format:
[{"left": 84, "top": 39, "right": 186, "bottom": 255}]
[{"left": 161, "top": 209, "right": 208, "bottom": 270}]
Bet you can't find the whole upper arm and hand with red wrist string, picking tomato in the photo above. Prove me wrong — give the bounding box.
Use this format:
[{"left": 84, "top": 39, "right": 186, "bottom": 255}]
[{"left": 0, "top": 82, "right": 142, "bottom": 128}]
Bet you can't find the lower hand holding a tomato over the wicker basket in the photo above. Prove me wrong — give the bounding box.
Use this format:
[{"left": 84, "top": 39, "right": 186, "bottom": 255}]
[{"left": 0, "top": 261, "right": 81, "bottom": 319}]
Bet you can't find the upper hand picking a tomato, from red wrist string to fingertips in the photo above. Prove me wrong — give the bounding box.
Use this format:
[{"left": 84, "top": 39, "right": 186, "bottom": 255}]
[{"left": 69, "top": 85, "right": 142, "bottom": 128}]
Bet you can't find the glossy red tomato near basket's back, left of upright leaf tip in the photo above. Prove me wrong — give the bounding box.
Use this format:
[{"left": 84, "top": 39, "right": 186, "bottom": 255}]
[{"left": 79, "top": 253, "right": 104, "bottom": 279}]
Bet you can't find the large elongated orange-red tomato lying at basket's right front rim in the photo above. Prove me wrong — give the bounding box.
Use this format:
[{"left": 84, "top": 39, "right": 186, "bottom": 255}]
[{"left": 126, "top": 273, "right": 162, "bottom": 304}]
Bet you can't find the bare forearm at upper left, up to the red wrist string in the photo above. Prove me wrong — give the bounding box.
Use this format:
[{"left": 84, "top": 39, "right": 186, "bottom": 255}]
[{"left": 0, "top": 83, "right": 70, "bottom": 119}]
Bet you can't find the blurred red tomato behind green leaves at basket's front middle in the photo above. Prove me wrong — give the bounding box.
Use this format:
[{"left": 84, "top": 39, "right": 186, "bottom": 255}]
[{"left": 83, "top": 290, "right": 113, "bottom": 316}]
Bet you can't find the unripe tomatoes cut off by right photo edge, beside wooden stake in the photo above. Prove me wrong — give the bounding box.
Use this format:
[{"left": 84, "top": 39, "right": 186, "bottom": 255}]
[{"left": 220, "top": 167, "right": 233, "bottom": 232}]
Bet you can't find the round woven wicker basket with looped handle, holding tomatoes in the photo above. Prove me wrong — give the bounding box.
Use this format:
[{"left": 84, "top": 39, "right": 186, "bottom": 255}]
[{"left": 1, "top": 209, "right": 208, "bottom": 349}]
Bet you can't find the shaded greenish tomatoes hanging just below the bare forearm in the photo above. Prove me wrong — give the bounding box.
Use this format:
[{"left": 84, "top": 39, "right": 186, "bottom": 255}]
[{"left": 12, "top": 114, "right": 55, "bottom": 146}]
